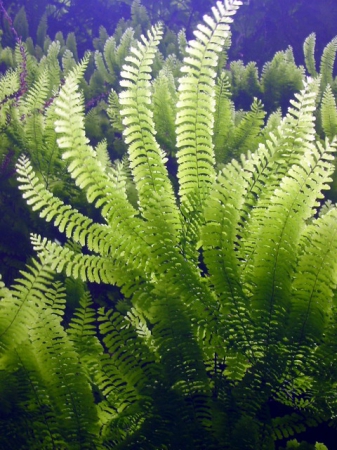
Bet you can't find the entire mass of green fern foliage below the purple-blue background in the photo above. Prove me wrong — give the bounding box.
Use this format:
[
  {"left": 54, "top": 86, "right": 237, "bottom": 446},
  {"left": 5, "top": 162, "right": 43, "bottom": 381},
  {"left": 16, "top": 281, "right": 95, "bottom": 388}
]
[{"left": 0, "top": 1, "right": 337, "bottom": 450}]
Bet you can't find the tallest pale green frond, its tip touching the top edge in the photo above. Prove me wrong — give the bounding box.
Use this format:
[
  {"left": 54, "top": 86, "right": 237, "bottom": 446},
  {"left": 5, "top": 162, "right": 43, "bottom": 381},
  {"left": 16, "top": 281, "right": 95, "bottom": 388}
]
[{"left": 176, "top": 1, "right": 240, "bottom": 203}]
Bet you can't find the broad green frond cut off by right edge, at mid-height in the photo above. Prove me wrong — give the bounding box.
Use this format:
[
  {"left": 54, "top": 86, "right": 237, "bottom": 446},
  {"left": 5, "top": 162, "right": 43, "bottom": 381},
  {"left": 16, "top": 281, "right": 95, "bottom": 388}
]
[{"left": 289, "top": 201, "right": 337, "bottom": 356}]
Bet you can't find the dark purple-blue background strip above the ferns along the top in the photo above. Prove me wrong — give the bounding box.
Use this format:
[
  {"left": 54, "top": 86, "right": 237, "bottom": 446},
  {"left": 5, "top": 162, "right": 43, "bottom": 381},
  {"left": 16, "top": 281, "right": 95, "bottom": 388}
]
[{"left": 0, "top": 0, "right": 337, "bottom": 67}]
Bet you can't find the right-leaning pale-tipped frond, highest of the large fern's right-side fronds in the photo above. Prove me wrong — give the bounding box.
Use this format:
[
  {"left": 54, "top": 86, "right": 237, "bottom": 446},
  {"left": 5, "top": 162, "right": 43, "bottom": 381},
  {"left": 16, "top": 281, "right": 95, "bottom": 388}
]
[{"left": 239, "top": 81, "right": 318, "bottom": 264}]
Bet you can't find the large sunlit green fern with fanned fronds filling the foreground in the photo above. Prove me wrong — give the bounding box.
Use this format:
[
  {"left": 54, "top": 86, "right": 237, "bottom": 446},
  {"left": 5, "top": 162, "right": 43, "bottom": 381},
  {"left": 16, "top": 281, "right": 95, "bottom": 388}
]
[{"left": 5, "top": 1, "right": 337, "bottom": 450}]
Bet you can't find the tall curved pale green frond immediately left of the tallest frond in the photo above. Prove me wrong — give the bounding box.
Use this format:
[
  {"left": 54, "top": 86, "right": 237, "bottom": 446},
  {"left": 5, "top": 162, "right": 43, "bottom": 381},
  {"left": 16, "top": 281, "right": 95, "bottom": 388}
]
[{"left": 119, "top": 25, "right": 180, "bottom": 236}]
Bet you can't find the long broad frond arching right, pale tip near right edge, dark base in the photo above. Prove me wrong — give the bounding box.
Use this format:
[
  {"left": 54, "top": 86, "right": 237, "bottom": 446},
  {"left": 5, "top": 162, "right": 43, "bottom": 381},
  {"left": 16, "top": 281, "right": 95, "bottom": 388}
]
[{"left": 245, "top": 135, "right": 334, "bottom": 349}]
